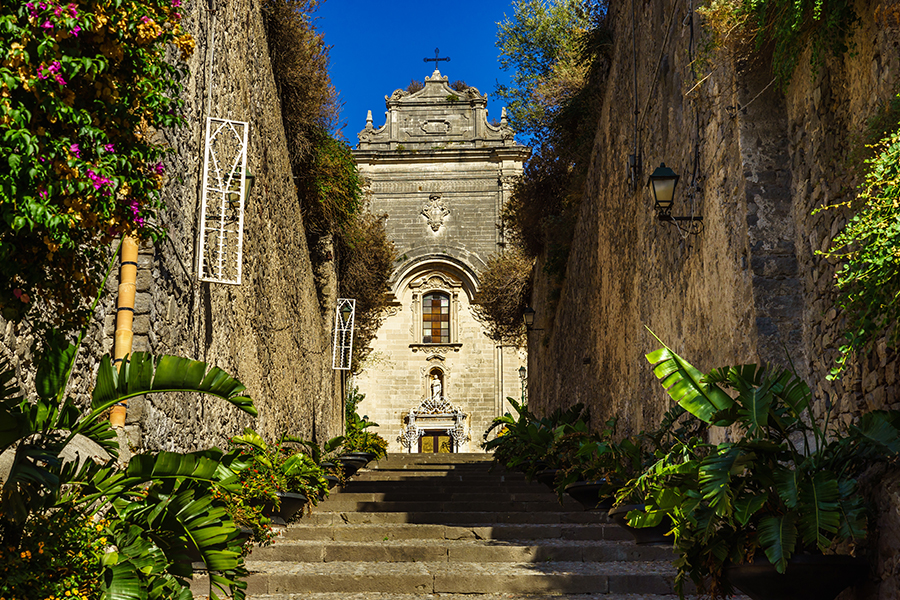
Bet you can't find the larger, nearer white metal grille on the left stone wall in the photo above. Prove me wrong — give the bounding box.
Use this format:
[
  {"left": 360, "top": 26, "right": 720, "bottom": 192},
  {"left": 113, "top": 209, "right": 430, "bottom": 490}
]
[{"left": 198, "top": 117, "right": 250, "bottom": 285}]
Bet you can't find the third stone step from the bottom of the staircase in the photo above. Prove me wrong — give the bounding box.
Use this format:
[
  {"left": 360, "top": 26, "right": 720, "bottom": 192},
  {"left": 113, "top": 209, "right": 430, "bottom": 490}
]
[{"left": 279, "top": 521, "right": 631, "bottom": 543}]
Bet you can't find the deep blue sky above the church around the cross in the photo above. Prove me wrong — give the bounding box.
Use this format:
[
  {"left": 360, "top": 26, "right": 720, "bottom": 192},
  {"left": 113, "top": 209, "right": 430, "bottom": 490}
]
[{"left": 313, "top": 0, "right": 513, "bottom": 146}]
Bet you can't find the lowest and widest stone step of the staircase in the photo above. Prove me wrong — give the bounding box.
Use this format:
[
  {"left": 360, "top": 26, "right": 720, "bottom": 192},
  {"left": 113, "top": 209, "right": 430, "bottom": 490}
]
[{"left": 191, "top": 560, "right": 675, "bottom": 595}]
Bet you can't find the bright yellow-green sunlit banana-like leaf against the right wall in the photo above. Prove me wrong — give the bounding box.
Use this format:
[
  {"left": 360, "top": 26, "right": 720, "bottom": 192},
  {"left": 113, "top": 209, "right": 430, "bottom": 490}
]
[{"left": 647, "top": 331, "right": 734, "bottom": 423}]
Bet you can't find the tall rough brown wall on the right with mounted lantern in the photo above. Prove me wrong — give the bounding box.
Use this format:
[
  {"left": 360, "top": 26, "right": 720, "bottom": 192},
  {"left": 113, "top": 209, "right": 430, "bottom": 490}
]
[{"left": 529, "top": 0, "right": 900, "bottom": 598}]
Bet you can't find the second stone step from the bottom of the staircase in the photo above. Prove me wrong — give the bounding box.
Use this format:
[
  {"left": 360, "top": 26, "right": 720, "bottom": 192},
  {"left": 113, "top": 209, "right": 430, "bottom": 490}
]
[{"left": 250, "top": 538, "right": 674, "bottom": 563}]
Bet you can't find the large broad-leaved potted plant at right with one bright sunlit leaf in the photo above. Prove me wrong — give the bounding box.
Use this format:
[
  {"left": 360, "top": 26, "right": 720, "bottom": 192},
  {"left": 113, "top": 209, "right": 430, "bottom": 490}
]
[{"left": 637, "top": 346, "right": 900, "bottom": 598}]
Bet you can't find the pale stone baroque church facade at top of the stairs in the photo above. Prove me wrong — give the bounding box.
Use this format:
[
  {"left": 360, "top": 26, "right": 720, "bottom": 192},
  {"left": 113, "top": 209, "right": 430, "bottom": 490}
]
[{"left": 353, "top": 69, "right": 531, "bottom": 452}]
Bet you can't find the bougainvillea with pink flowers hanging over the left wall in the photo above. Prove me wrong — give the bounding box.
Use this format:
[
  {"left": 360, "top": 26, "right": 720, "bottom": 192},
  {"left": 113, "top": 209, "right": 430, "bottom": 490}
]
[{"left": 0, "top": 0, "right": 194, "bottom": 329}]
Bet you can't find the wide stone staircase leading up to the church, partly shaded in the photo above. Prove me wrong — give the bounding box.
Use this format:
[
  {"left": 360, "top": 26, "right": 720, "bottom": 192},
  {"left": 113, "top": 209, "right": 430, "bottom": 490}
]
[{"left": 194, "top": 454, "right": 692, "bottom": 600}]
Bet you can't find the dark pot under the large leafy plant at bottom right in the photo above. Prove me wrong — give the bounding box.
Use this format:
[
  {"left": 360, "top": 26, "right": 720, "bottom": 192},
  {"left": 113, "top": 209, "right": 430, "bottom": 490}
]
[{"left": 725, "top": 554, "right": 869, "bottom": 600}]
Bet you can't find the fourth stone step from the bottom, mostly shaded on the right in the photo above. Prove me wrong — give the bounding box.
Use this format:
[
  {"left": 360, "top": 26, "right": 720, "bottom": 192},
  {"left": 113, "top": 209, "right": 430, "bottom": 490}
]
[{"left": 301, "top": 510, "right": 609, "bottom": 525}]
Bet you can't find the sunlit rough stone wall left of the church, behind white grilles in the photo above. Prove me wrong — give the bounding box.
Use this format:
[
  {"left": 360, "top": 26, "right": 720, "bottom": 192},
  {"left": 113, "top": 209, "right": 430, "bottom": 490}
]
[{"left": 0, "top": 0, "right": 343, "bottom": 450}]
